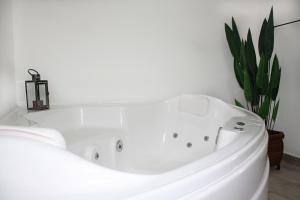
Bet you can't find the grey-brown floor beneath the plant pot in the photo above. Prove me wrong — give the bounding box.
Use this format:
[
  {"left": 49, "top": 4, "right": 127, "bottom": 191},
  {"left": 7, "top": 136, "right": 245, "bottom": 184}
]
[{"left": 269, "top": 159, "right": 300, "bottom": 200}]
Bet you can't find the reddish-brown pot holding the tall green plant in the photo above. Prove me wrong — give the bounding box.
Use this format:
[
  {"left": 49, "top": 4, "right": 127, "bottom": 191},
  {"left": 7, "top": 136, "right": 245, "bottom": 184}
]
[{"left": 268, "top": 130, "right": 284, "bottom": 170}]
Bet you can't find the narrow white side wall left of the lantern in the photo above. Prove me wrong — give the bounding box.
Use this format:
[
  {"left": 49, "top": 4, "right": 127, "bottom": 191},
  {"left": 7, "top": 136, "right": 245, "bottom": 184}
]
[{"left": 0, "top": 0, "right": 16, "bottom": 116}]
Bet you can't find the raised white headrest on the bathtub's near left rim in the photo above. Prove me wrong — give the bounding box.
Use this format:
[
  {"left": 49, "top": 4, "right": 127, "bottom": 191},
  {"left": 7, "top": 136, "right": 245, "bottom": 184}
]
[{"left": 0, "top": 126, "right": 66, "bottom": 149}]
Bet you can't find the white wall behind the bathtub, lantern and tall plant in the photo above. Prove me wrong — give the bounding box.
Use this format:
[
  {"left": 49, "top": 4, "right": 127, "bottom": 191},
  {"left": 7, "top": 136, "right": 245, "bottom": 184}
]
[{"left": 14, "top": 0, "right": 300, "bottom": 156}]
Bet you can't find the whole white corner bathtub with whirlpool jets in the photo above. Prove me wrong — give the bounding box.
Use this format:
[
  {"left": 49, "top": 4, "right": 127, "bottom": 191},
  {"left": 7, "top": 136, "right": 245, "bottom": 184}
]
[{"left": 0, "top": 95, "right": 269, "bottom": 200}]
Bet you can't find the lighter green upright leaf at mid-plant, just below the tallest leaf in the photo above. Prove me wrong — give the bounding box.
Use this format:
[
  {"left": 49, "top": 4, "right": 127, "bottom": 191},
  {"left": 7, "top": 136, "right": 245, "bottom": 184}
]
[{"left": 256, "top": 54, "right": 269, "bottom": 95}]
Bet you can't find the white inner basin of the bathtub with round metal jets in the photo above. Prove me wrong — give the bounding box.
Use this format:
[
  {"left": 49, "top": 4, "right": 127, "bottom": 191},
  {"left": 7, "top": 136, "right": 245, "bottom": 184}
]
[{"left": 19, "top": 95, "right": 246, "bottom": 174}]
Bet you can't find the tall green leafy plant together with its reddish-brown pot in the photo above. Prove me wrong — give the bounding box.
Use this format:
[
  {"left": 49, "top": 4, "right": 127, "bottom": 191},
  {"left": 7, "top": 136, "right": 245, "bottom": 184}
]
[{"left": 225, "top": 8, "right": 284, "bottom": 169}]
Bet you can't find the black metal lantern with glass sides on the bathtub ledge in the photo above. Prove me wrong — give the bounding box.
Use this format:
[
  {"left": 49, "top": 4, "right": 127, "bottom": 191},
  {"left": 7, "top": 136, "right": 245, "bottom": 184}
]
[{"left": 25, "top": 69, "right": 50, "bottom": 110}]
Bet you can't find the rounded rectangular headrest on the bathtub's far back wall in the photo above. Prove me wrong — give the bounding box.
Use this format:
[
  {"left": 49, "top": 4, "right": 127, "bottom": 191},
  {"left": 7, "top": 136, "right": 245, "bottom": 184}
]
[{"left": 178, "top": 95, "right": 209, "bottom": 116}]
